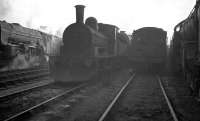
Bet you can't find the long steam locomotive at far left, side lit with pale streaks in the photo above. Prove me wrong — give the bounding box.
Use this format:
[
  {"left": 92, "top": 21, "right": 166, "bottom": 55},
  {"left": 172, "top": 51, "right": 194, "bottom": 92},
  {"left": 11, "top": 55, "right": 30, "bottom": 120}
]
[{"left": 0, "top": 21, "right": 62, "bottom": 71}]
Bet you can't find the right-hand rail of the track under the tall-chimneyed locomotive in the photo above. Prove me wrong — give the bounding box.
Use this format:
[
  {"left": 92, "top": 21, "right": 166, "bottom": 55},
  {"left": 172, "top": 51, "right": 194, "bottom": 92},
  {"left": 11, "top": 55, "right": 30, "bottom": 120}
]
[{"left": 3, "top": 84, "right": 87, "bottom": 121}]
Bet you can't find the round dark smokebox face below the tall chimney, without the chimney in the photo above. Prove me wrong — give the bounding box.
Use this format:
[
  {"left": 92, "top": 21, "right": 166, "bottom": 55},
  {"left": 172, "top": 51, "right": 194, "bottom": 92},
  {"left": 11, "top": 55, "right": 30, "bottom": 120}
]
[{"left": 63, "top": 23, "right": 92, "bottom": 58}]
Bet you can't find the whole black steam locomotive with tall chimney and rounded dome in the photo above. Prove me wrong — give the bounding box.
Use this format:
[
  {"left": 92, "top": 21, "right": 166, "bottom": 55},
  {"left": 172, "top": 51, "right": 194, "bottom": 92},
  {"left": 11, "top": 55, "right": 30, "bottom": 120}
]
[{"left": 52, "top": 5, "right": 130, "bottom": 82}]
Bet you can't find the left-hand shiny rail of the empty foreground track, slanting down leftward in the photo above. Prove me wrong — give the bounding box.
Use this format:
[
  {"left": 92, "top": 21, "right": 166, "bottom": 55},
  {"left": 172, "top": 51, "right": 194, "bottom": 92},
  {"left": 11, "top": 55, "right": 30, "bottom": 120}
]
[{"left": 98, "top": 74, "right": 135, "bottom": 121}]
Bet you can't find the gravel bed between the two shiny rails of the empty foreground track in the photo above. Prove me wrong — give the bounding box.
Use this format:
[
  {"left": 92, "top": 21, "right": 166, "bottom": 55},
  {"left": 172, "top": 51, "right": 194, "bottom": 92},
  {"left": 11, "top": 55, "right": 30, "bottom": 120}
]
[{"left": 103, "top": 75, "right": 173, "bottom": 121}]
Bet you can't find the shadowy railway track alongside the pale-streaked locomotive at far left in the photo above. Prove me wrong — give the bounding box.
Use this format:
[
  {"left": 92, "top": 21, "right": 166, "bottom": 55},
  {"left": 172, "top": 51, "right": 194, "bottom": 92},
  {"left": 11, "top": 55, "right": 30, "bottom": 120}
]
[{"left": 0, "top": 66, "right": 53, "bottom": 98}]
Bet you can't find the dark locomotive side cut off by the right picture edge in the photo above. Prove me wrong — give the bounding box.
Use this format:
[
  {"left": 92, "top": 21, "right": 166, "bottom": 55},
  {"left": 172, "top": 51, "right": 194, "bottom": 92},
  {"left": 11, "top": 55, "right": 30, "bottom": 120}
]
[{"left": 170, "top": 0, "right": 200, "bottom": 96}]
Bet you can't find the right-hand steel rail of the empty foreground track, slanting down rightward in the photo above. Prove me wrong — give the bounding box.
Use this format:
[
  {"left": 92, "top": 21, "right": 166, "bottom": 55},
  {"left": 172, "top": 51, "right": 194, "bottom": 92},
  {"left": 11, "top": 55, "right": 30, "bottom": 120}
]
[{"left": 157, "top": 76, "right": 178, "bottom": 121}]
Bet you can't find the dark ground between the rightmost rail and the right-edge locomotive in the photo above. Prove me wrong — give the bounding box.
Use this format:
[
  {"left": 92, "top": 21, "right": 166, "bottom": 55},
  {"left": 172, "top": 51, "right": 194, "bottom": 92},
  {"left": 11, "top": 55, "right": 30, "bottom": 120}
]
[{"left": 163, "top": 76, "right": 200, "bottom": 121}]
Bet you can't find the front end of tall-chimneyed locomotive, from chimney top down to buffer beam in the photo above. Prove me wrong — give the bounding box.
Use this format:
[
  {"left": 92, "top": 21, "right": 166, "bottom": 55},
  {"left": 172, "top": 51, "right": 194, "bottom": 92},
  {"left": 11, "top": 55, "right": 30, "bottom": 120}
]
[{"left": 53, "top": 5, "right": 97, "bottom": 82}]
